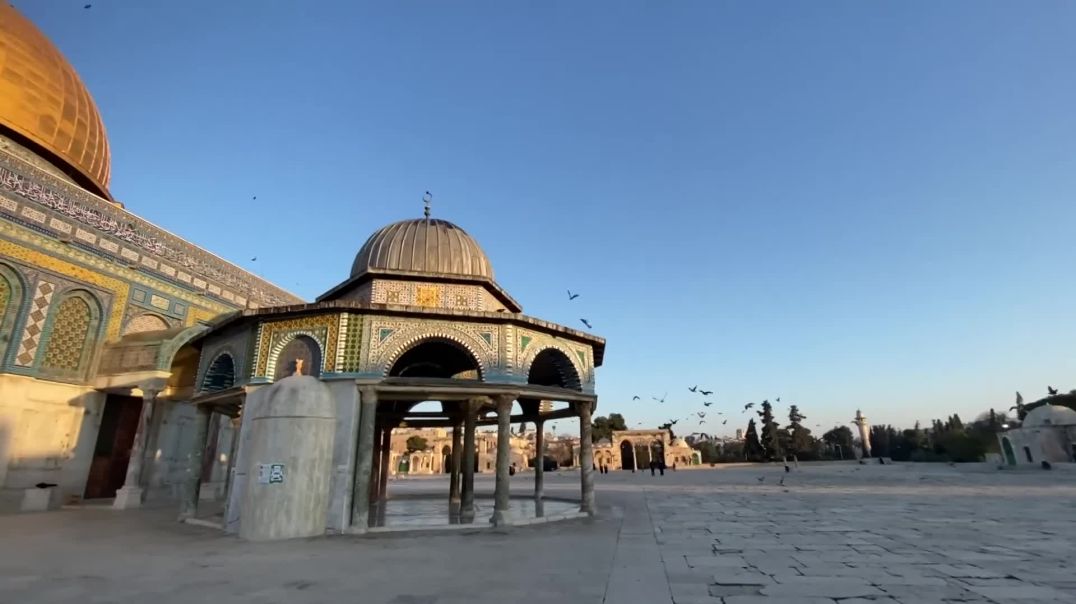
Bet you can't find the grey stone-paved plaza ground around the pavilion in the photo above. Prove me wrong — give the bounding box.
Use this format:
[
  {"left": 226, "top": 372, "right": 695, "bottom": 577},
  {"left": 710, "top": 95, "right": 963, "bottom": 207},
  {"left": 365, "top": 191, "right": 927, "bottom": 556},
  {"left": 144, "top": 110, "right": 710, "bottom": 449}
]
[{"left": 0, "top": 464, "right": 1076, "bottom": 604}]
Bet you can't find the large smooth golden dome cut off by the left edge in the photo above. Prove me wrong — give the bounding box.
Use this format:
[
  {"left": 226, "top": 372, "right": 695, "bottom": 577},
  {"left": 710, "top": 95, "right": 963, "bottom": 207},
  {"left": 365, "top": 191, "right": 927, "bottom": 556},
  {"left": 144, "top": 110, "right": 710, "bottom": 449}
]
[{"left": 0, "top": 1, "right": 111, "bottom": 199}]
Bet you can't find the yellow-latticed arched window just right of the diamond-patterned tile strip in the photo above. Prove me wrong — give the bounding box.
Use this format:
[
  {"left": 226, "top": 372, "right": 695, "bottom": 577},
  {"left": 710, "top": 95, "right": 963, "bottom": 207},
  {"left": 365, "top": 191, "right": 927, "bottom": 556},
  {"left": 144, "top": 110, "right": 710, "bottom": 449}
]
[{"left": 39, "top": 292, "right": 101, "bottom": 378}]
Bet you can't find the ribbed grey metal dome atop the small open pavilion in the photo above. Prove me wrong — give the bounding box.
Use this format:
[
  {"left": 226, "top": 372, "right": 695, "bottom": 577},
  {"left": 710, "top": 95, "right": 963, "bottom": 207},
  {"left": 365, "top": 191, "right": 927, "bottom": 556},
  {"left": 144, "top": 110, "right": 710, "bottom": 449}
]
[{"left": 351, "top": 219, "right": 493, "bottom": 281}]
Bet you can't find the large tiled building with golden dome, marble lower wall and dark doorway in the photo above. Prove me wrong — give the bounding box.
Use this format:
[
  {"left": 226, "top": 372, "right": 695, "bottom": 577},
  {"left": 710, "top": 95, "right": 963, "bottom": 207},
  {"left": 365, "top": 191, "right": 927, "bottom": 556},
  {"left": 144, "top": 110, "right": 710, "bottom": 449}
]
[{"left": 0, "top": 2, "right": 301, "bottom": 509}]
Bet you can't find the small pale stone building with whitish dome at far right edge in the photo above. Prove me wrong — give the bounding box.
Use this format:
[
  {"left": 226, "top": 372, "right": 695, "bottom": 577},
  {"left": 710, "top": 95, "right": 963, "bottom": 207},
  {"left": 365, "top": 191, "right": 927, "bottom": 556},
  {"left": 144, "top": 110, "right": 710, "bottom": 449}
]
[{"left": 997, "top": 405, "right": 1076, "bottom": 465}]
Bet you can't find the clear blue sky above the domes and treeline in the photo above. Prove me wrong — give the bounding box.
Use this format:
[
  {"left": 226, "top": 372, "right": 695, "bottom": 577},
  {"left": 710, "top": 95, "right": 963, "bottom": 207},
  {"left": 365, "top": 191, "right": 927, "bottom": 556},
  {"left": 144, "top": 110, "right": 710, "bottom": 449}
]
[{"left": 16, "top": 0, "right": 1076, "bottom": 432}]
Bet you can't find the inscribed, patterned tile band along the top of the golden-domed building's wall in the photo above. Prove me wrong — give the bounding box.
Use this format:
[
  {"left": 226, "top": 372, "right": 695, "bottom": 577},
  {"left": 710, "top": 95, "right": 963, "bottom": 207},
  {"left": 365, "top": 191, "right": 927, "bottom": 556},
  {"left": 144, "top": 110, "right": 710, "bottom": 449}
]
[{"left": 0, "top": 153, "right": 300, "bottom": 306}]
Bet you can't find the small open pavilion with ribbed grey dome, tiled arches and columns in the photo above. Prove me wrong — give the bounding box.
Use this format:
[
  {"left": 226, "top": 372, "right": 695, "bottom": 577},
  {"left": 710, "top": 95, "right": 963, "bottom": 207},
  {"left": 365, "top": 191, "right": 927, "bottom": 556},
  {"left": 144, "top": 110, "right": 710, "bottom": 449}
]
[{"left": 181, "top": 215, "right": 605, "bottom": 532}]
